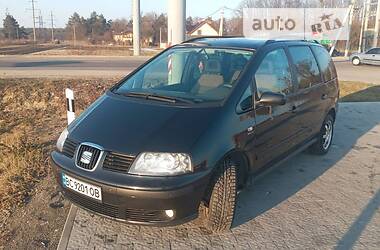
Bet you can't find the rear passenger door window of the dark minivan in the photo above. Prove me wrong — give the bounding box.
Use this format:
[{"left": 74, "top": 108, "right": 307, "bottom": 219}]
[{"left": 289, "top": 46, "right": 321, "bottom": 89}]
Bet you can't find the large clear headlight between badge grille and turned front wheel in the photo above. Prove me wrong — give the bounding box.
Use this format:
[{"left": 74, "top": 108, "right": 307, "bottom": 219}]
[{"left": 129, "top": 153, "right": 193, "bottom": 176}]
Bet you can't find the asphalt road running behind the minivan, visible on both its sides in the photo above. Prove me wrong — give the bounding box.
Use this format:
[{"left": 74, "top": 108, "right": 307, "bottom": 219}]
[{"left": 0, "top": 55, "right": 380, "bottom": 84}]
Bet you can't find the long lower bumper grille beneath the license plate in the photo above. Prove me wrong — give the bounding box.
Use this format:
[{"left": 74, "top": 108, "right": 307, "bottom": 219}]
[{"left": 64, "top": 190, "right": 170, "bottom": 223}]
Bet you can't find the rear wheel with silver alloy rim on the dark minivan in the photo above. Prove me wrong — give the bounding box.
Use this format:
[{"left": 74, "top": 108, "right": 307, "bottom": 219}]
[{"left": 309, "top": 114, "right": 334, "bottom": 155}]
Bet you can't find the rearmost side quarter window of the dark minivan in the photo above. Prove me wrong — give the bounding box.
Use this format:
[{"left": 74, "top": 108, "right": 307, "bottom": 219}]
[{"left": 311, "top": 46, "right": 336, "bottom": 81}]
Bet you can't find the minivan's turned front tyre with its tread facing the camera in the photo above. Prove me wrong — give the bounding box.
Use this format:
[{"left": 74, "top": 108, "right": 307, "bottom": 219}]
[{"left": 205, "top": 159, "right": 237, "bottom": 232}]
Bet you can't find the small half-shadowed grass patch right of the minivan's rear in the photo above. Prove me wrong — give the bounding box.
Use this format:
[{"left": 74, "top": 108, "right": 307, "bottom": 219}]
[{"left": 339, "top": 81, "right": 380, "bottom": 102}]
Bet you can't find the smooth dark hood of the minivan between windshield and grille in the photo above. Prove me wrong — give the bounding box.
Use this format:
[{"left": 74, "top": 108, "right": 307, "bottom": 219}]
[{"left": 68, "top": 92, "right": 220, "bottom": 155}]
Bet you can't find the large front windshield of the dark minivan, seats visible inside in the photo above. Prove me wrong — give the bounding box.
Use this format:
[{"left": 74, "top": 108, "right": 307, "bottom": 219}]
[{"left": 114, "top": 46, "right": 253, "bottom": 103}]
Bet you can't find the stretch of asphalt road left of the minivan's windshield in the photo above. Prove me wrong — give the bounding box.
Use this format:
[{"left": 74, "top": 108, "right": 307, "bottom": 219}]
[{"left": 0, "top": 56, "right": 150, "bottom": 78}]
